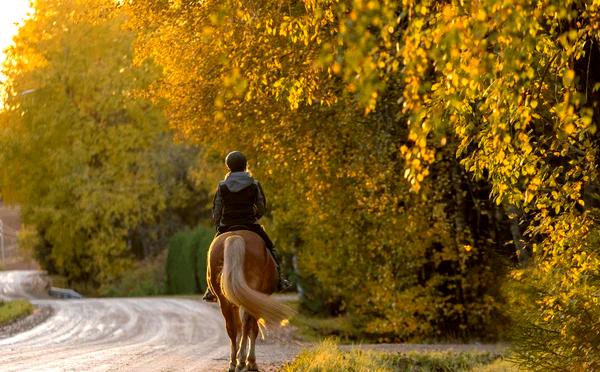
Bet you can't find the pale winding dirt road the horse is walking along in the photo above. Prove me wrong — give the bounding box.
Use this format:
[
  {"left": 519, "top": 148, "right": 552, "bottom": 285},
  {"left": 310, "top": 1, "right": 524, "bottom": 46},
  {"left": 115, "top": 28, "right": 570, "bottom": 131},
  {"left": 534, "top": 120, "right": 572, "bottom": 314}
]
[{"left": 0, "top": 272, "right": 297, "bottom": 371}]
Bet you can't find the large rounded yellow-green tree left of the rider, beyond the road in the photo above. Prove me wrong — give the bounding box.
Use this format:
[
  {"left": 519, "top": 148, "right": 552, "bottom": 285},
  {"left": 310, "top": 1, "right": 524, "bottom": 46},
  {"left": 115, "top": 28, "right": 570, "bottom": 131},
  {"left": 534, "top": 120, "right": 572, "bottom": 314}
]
[{"left": 0, "top": 0, "right": 202, "bottom": 286}]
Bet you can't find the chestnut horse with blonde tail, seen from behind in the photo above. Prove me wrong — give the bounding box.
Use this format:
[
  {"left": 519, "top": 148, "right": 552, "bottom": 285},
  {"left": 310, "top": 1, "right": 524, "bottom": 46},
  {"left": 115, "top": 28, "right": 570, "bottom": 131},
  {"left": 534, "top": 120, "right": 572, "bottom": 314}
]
[{"left": 206, "top": 230, "right": 294, "bottom": 372}]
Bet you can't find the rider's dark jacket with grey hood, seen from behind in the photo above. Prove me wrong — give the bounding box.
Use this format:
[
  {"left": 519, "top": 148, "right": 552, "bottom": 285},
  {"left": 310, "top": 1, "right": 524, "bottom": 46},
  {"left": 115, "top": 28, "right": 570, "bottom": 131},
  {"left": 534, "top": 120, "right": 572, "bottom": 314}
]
[{"left": 213, "top": 172, "right": 266, "bottom": 227}]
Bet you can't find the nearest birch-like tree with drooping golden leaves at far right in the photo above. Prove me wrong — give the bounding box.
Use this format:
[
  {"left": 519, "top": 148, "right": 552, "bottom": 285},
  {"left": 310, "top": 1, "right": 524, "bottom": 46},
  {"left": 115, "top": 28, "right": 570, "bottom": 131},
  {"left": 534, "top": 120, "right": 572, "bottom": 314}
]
[{"left": 330, "top": 0, "right": 600, "bottom": 370}]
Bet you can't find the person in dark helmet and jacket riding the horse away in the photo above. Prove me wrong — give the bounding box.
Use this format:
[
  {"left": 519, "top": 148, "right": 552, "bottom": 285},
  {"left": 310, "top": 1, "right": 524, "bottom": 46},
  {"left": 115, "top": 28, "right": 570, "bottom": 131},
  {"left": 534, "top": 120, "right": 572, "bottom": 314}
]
[{"left": 203, "top": 151, "right": 289, "bottom": 302}]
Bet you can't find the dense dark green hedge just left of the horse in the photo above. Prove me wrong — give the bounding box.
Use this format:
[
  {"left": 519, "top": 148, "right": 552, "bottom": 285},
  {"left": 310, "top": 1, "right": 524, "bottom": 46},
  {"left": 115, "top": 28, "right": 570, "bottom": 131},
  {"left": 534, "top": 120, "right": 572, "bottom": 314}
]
[{"left": 166, "top": 222, "right": 214, "bottom": 294}]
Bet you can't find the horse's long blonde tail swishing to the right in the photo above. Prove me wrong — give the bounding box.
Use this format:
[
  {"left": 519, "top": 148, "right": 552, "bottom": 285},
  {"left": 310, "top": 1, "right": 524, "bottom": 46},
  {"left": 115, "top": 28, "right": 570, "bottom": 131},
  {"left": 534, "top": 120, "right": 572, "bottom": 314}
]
[{"left": 221, "top": 235, "right": 294, "bottom": 325}]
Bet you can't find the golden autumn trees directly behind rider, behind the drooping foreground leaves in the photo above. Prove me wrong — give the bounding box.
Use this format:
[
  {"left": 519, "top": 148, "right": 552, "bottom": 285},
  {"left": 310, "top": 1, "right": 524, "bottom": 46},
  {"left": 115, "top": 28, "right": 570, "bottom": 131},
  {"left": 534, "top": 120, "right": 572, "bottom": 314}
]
[{"left": 128, "top": 1, "right": 511, "bottom": 340}]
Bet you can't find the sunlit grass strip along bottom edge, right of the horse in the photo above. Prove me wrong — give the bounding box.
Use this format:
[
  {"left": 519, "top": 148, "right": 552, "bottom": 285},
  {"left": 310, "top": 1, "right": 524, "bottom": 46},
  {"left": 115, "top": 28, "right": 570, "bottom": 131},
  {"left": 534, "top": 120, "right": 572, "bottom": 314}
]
[{"left": 283, "top": 340, "right": 510, "bottom": 372}]
